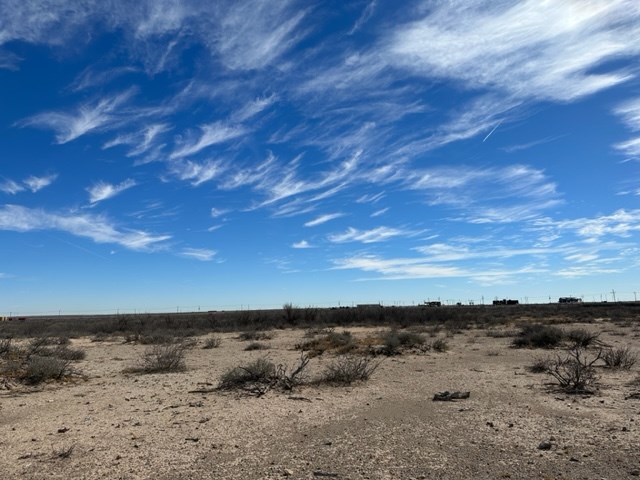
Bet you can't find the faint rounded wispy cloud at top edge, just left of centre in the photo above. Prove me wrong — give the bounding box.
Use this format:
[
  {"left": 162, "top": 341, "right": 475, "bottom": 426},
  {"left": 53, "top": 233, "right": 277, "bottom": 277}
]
[{"left": 210, "top": 0, "right": 306, "bottom": 70}]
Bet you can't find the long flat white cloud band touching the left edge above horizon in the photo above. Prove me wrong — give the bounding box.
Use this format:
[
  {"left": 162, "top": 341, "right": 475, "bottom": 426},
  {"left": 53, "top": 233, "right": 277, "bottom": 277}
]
[{"left": 0, "top": 205, "right": 171, "bottom": 251}]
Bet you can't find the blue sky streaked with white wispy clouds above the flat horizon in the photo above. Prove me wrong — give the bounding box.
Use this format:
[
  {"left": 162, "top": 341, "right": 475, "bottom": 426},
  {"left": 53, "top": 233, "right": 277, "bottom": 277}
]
[{"left": 0, "top": 0, "right": 640, "bottom": 314}]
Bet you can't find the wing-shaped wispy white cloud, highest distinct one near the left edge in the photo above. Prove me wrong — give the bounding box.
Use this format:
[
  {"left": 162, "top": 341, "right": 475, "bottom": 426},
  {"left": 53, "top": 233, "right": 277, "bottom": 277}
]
[{"left": 16, "top": 89, "right": 134, "bottom": 144}]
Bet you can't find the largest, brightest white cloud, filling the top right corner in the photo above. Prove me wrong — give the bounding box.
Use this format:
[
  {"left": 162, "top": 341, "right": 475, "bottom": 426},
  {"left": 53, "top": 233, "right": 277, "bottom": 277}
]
[{"left": 387, "top": 0, "right": 640, "bottom": 101}]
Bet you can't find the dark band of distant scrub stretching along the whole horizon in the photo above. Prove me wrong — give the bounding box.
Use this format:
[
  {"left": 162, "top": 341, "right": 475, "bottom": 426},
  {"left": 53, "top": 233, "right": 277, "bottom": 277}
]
[{"left": 0, "top": 302, "right": 640, "bottom": 338}]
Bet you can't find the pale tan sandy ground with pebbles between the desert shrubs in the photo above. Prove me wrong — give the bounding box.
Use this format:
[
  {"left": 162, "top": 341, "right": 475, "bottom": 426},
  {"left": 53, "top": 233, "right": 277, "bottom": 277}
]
[{"left": 0, "top": 323, "right": 640, "bottom": 480}]
